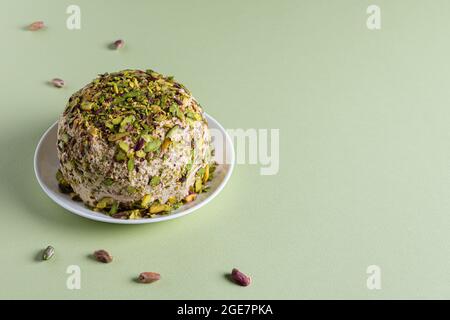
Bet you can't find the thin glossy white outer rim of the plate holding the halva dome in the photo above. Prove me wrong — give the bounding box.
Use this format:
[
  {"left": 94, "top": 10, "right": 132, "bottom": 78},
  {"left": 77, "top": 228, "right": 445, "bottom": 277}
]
[{"left": 33, "top": 112, "right": 236, "bottom": 225}]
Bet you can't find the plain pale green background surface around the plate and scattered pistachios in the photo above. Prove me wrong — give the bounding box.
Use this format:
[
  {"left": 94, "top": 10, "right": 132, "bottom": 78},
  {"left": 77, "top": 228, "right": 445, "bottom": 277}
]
[{"left": 0, "top": 0, "right": 450, "bottom": 299}]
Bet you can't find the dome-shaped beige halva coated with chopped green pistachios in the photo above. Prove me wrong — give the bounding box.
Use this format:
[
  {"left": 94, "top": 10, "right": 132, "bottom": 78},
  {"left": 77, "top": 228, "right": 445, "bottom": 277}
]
[{"left": 57, "top": 70, "right": 215, "bottom": 219}]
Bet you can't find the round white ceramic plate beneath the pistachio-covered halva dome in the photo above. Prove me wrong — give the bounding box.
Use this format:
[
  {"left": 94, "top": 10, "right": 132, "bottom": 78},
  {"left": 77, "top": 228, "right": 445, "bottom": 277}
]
[{"left": 34, "top": 115, "right": 234, "bottom": 224}]
